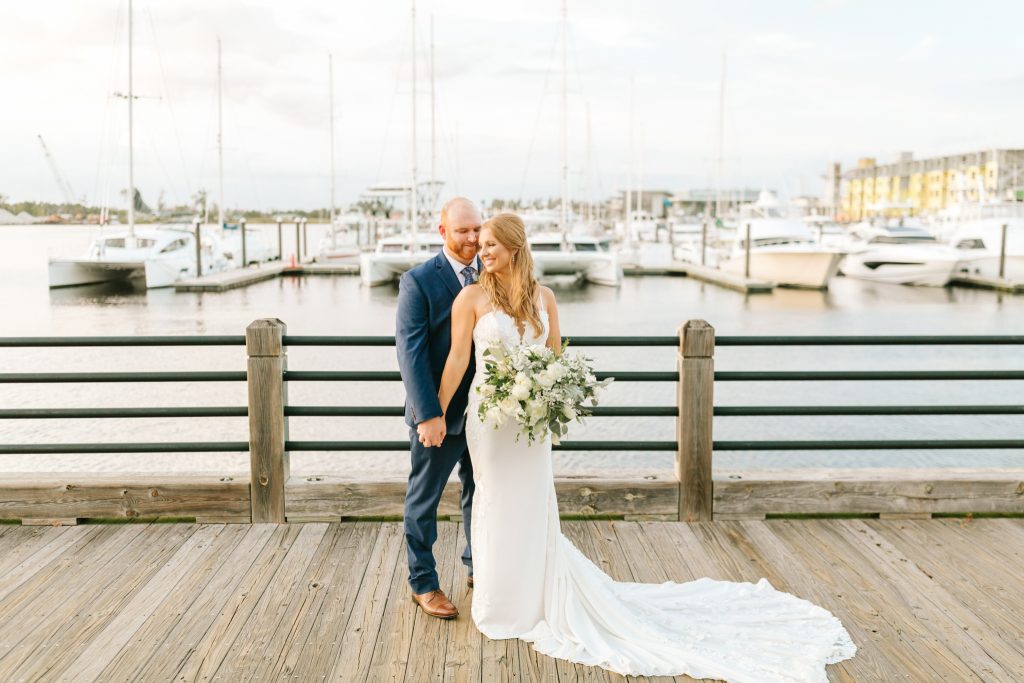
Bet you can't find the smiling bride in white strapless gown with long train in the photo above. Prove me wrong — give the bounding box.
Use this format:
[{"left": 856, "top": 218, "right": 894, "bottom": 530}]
[{"left": 438, "top": 213, "right": 856, "bottom": 683}]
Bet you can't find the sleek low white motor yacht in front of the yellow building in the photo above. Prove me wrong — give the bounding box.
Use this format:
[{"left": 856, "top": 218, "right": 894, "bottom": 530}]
[{"left": 842, "top": 221, "right": 959, "bottom": 287}]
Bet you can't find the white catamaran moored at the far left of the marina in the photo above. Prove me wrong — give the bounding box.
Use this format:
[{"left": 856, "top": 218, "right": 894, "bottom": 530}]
[{"left": 49, "top": 227, "right": 228, "bottom": 289}]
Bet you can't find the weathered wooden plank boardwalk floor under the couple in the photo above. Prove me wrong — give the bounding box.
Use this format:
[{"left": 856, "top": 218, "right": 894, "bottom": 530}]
[{"left": 0, "top": 518, "right": 1024, "bottom": 683}]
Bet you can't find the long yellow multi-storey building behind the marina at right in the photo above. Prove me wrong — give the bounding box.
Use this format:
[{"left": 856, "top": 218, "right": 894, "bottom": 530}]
[{"left": 839, "top": 150, "right": 1024, "bottom": 220}]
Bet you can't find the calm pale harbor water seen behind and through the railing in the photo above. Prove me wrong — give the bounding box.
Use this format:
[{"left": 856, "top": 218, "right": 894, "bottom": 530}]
[{"left": 0, "top": 224, "right": 1024, "bottom": 478}]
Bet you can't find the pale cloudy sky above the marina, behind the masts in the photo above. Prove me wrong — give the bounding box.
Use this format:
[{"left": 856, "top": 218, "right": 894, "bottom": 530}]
[{"left": 0, "top": 0, "right": 1024, "bottom": 209}]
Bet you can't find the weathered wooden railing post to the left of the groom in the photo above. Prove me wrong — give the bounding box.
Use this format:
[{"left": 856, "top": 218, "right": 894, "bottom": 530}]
[{"left": 246, "top": 318, "right": 291, "bottom": 524}]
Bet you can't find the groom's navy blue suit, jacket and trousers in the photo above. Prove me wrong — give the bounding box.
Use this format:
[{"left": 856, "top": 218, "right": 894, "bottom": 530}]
[{"left": 395, "top": 251, "right": 480, "bottom": 594}]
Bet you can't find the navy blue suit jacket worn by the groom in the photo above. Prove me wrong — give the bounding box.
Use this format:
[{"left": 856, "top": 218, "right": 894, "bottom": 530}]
[{"left": 395, "top": 251, "right": 480, "bottom": 434}]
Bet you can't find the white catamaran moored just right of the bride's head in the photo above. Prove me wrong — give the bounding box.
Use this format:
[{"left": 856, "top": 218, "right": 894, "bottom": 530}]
[{"left": 528, "top": 231, "right": 623, "bottom": 287}]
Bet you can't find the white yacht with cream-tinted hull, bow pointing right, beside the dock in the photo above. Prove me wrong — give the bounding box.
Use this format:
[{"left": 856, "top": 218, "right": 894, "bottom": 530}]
[{"left": 708, "top": 190, "right": 843, "bottom": 289}]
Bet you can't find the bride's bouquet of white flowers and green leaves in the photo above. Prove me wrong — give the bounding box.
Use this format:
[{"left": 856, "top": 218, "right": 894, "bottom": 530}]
[{"left": 476, "top": 341, "right": 612, "bottom": 444}]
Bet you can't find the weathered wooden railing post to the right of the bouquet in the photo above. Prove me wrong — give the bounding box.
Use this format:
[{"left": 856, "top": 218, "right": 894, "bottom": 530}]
[{"left": 676, "top": 321, "right": 715, "bottom": 522}]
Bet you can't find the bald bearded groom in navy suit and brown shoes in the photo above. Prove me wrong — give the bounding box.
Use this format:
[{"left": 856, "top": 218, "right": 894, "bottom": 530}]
[{"left": 395, "top": 197, "right": 483, "bottom": 618}]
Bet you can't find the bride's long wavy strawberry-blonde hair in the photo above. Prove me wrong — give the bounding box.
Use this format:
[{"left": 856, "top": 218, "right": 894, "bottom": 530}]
[{"left": 479, "top": 213, "right": 544, "bottom": 335}]
